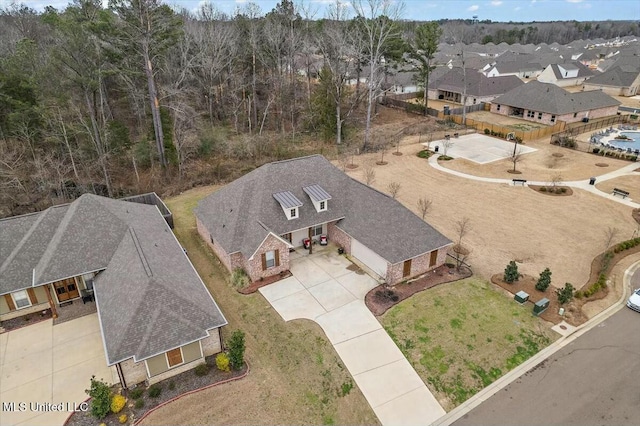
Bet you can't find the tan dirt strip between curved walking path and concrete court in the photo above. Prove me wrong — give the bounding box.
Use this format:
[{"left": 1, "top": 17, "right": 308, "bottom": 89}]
[{"left": 430, "top": 138, "right": 629, "bottom": 181}]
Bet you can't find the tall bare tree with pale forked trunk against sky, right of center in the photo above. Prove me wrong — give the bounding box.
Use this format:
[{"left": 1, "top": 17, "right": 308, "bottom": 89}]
[{"left": 353, "top": 0, "right": 404, "bottom": 152}]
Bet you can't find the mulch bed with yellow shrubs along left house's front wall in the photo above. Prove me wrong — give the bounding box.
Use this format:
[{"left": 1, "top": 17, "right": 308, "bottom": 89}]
[{"left": 65, "top": 355, "right": 249, "bottom": 426}]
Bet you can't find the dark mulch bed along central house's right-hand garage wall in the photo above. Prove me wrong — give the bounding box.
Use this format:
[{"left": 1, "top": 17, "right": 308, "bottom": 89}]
[{"left": 364, "top": 264, "right": 471, "bottom": 316}]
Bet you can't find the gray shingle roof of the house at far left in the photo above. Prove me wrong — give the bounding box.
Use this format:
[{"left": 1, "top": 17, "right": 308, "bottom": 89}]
[{"left": 0, "top": 194, "right": 226, "bottom": 364}]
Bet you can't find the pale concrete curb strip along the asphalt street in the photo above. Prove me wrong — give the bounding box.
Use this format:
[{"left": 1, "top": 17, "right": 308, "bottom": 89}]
[{"left": 431, "top": 260, "right": 640, "bottom": 426}]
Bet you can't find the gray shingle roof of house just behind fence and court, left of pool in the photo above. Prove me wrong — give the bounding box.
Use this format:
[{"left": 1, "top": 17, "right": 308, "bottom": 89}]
[{"left": 493, "top": 81, "right": 620, "bottom": 115}]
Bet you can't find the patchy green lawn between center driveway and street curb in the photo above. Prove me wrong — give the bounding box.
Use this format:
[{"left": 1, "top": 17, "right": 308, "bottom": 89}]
[{"left": 380, "top": 277, "right": 559, "bottom": 411}]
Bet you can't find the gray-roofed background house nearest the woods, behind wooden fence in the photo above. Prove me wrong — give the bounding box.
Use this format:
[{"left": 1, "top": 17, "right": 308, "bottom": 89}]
[{"left": 428, "top": 68, "right": 524, "bottom": 105}]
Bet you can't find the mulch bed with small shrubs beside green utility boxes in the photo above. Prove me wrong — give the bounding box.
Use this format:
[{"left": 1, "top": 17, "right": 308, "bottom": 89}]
[{"left": 491, "top": 274, "right": 592, "bottom": 326}]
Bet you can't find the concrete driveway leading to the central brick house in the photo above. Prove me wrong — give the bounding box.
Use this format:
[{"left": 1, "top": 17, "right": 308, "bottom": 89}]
[{"left": 260, "top": 251, "right": 445, "bottom": 425}]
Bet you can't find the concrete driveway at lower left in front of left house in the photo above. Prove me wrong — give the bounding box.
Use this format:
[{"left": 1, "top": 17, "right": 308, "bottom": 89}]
[{"left": 0, "top": 314, "right": 117, "bottom": 425}]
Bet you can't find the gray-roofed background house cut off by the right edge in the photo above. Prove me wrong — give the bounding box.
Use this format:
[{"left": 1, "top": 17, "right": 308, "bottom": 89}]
[{"left": 584, "top": 56, "right": 640, "bottom": 96}]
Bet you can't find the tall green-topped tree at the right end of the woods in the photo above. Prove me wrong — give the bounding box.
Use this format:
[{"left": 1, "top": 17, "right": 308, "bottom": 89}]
[{"left": 408, "top": 22, "right": 442, "bottom": 115}]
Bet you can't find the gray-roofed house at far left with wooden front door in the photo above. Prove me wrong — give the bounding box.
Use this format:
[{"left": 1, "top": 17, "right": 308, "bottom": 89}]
[{"left": 0, "top": 194, "right": 227, "bottom": 387}]
